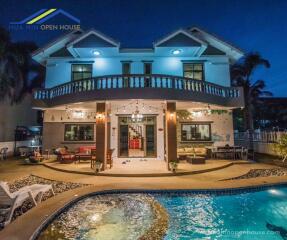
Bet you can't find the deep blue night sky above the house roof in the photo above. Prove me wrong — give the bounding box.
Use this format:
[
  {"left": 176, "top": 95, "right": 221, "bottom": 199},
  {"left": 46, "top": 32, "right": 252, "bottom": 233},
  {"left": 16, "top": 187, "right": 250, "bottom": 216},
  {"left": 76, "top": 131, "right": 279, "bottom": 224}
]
[{"left": 0, "top": 0, "right": 287, "bottom": 97}]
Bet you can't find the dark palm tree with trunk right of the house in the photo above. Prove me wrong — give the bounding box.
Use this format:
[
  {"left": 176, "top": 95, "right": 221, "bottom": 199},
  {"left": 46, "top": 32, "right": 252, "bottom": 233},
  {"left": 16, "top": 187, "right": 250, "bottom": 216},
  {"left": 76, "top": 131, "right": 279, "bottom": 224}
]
[{"left": 231, "top": 53, "right": 272, "bottom": 131}]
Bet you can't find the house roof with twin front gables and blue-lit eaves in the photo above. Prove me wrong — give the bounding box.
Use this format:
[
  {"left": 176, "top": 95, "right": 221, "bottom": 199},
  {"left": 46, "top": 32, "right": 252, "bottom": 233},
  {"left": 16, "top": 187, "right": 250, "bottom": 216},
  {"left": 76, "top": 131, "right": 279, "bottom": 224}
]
[{"left": 32, "top": 27, "right": 244, "bottom": 64}]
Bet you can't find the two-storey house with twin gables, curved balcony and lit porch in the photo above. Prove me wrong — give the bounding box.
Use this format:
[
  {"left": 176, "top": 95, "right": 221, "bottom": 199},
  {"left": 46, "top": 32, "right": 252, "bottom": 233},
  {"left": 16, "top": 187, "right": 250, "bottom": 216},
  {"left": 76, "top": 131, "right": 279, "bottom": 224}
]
[{"left": 33, "top": 28, "right": 244, "bottom": 170}]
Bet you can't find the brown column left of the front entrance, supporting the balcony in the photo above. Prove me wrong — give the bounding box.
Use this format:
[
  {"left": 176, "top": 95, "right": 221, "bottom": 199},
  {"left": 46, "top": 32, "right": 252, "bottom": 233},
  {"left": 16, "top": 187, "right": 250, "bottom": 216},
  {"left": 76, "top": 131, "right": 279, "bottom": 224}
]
[{"left": 96, "top": 103, "right": 107, "bottom": 170}]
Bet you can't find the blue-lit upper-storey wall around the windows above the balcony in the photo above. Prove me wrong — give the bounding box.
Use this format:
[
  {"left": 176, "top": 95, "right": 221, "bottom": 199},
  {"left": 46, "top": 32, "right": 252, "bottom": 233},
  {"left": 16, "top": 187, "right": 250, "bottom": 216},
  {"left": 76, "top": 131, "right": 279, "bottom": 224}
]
[{"left": 45, "top": 56, "right": 233, "bottom": 88}]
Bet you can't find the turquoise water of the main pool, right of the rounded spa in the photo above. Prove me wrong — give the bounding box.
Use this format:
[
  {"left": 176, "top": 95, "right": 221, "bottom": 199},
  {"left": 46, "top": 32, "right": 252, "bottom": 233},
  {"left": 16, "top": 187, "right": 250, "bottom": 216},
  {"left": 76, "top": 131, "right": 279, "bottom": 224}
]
[{"left": 156, "top": 188, "right": 287, "bottom": 240}]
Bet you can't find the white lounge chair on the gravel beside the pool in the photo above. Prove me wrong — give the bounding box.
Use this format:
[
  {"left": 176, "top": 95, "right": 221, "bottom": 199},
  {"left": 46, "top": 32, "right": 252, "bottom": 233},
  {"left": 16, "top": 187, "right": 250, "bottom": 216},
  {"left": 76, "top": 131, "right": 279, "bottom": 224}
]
[{"left": 0, "top": 181, "right": 55, "bottom": 226}]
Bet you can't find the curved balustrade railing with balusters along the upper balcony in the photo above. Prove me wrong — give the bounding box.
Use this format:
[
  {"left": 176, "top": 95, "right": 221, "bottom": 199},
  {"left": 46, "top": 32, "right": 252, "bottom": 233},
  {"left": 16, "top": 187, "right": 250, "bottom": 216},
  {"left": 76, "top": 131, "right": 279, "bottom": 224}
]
[{"left": 34, "top": 74, "right": 242, "bottom": 100}]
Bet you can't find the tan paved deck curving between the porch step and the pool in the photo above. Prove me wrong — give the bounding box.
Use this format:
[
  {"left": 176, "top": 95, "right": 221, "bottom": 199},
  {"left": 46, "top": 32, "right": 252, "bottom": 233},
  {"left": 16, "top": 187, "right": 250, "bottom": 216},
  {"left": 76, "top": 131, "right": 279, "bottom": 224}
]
[{"left": 0, "top": 160, "right": 287, "bottom": 240}]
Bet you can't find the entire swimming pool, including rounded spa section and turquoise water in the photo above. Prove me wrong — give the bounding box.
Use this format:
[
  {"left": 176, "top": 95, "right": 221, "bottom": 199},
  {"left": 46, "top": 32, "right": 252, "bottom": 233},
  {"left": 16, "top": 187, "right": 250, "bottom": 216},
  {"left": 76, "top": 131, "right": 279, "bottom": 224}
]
[{"left": 38, "top": 187, "right": 287, "bottom": 240}]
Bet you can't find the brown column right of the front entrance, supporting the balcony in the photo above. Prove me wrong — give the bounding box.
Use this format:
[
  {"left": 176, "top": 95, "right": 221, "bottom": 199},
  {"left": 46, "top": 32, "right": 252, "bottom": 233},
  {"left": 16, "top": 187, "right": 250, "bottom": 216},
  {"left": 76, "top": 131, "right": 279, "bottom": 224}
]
[{"left": 166, "top": 102, "right": 177, "bottom": 169}]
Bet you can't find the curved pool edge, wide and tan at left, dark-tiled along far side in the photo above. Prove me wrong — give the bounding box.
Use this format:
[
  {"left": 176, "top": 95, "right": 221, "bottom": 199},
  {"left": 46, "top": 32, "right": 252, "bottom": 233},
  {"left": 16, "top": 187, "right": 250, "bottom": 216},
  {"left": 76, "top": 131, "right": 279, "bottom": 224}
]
[{"left": 0, "top": 181, "right": 287, "bottom": 240}]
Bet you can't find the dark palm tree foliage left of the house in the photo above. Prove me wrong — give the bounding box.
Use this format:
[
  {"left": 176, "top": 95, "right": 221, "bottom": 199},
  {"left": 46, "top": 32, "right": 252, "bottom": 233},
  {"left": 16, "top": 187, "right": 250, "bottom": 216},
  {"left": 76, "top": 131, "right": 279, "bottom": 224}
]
[{"left": 0, "top": 26, "right": 44, "bottom": 104}]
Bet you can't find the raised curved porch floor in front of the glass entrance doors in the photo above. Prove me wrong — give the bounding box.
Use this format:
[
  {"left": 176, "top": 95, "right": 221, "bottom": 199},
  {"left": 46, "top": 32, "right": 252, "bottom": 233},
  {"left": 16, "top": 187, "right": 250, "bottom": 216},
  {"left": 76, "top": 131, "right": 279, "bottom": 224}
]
[{"left": 44, "top": 159, "right": 247, "bottom": 177}]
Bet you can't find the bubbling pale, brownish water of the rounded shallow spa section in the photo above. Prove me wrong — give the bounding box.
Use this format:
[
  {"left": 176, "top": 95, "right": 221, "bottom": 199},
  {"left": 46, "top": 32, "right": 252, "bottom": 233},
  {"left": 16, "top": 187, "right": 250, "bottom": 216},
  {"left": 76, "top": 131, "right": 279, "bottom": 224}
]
[{"left": 38, "top": 194, "right": 156, "bottom": 240}]
